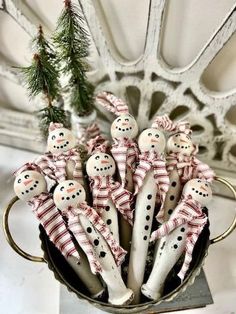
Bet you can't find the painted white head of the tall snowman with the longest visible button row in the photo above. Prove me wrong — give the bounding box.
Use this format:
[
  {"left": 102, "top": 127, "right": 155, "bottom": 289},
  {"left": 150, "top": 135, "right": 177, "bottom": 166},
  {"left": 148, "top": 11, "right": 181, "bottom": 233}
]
[{"left": 138, "top": 128, "right": 166, "bottom": 154}]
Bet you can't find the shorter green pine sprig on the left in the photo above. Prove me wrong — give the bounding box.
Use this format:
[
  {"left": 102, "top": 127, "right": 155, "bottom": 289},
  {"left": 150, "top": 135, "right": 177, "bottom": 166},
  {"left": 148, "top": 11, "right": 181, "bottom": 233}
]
[{"left": 20, "top": 26, "right": 70, "bottom": 136}]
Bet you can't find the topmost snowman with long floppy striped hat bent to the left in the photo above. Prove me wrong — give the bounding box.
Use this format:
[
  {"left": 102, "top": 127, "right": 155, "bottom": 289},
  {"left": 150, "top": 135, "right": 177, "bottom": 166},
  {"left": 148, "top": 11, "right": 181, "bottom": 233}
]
[{"left": 96, "top": 92, "right": 139, "bottom": 192}]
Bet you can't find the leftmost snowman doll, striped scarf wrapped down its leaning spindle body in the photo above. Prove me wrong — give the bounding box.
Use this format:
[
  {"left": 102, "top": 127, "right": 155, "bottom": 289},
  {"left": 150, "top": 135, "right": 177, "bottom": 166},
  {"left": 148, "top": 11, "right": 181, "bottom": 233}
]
[{"left": 14, "top": 163, "right": 104, "bottom": 297}]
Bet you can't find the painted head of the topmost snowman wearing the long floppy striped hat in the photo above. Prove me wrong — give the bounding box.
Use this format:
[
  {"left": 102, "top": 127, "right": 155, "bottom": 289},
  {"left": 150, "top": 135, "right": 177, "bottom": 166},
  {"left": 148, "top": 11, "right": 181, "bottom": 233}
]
[{"left": 111, "top": 114, "right": 138, "bottom": 139}]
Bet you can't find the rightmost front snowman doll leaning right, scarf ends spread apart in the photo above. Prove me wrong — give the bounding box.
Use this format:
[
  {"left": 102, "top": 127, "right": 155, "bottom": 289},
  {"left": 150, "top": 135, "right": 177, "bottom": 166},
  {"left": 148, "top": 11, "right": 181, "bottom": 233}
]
[{"left": 142, "top": 179, "right": 212, "bottom": 300}]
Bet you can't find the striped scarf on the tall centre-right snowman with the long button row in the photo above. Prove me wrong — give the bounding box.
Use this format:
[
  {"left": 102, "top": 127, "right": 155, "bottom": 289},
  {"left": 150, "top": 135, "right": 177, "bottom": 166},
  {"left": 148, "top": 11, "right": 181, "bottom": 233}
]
[{"left": 134, "top": 151, "right": 170, "bottom": 205}]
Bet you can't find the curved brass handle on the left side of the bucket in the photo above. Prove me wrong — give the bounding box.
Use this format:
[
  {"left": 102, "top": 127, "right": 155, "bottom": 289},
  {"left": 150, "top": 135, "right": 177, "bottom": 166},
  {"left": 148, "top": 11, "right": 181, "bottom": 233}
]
[{"left": 3, "top": 196, "right": 46, "bottom": 263}]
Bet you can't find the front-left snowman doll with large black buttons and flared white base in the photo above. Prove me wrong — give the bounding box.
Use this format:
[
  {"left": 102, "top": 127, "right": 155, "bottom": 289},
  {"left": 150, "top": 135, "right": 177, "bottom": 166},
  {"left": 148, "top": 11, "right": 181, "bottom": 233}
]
[{"left": 53, "top": 180, "right": 133, "bottom": 305}]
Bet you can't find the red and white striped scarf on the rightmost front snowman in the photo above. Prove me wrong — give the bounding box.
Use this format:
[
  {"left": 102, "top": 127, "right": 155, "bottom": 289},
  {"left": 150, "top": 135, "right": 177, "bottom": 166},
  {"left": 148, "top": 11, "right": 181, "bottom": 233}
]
[{"left": 150, "top": 195, "right": 207, "bottom": 280}]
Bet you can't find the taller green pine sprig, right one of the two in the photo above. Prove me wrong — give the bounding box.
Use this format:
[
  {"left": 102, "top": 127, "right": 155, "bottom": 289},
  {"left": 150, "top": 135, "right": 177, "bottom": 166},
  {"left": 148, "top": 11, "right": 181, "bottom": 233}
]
[{"left": 53, "top": 0, "right": 94, "bottom": 116}]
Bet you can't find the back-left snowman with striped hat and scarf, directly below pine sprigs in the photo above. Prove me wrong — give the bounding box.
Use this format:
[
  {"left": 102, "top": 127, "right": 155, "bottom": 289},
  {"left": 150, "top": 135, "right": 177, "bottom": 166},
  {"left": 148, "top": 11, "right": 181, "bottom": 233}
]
[{"left": 35, "top": 122, "right": 84, "bottom": 184}]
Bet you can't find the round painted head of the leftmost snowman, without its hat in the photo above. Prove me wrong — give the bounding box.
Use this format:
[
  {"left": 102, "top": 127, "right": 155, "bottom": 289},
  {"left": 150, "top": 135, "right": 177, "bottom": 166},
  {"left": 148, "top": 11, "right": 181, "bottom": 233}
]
[{"left": 14, "top": 170, "right": 47, "bottom": 201}]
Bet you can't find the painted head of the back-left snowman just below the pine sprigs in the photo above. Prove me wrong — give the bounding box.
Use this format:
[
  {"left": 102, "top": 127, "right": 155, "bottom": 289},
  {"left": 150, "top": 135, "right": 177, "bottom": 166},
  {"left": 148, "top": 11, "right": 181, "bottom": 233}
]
[{"left": 47, "top": 128, "right": 76, "bottom": 153}]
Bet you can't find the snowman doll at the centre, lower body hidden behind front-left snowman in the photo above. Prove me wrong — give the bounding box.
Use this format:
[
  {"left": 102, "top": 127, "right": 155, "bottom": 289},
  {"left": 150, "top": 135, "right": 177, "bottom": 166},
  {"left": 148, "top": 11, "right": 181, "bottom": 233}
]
[{"left": 86, "top": 147, "right": 133, "bottom": 247}]
